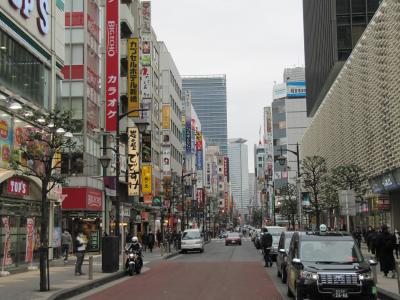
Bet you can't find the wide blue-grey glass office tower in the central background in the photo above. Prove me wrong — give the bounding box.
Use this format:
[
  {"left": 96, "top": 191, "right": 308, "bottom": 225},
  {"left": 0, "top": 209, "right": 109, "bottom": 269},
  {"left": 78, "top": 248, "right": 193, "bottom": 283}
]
[{"left": 182, "top": 75, "right": 228, "bottom": 155}]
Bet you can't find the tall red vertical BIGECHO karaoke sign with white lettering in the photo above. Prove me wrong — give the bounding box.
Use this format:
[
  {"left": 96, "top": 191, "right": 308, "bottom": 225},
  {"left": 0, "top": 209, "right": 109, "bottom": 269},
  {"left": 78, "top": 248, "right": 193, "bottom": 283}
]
[{"left": 106, "top": 0, "right": 119, "bottom": 131}]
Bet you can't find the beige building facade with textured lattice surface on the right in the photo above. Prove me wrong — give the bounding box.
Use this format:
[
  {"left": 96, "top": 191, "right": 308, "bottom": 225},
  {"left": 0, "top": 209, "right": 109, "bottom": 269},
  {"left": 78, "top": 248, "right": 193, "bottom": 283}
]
[{"left": 300, "top": 0, "right": 400, "bottom": 228}]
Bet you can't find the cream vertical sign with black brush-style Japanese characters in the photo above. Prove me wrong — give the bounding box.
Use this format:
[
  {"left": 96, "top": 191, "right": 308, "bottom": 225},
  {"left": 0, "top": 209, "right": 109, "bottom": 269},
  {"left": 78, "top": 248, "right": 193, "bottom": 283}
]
[{"left": 128, "top": 127, "right": 140, "bottom": 196}]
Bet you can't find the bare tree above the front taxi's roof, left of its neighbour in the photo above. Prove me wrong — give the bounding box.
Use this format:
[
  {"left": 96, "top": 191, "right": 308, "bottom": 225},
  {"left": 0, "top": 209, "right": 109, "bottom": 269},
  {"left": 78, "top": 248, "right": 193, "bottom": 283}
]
[{"left": 301, "top": 156, "right": 327, "bottom": 228}]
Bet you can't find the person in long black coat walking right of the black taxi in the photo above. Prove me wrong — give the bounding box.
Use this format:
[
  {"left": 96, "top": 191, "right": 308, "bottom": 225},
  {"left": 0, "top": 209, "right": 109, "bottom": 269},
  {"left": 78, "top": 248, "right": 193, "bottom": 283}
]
[{"left": 377, "top": 225, "right": 396, "bottom": 278}]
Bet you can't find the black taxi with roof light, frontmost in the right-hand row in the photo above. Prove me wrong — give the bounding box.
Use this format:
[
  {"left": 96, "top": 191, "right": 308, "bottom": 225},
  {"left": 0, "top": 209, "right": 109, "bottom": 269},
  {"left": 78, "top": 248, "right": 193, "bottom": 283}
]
[{"left": 287, "top": 225, "right": 377, "bottom": 299}]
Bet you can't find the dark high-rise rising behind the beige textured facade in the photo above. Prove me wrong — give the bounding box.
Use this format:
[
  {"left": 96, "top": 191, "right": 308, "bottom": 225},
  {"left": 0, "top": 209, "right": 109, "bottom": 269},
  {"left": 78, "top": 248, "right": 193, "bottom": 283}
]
[{"left": 303, "top": 0, "right": 380, "bottom": 116}]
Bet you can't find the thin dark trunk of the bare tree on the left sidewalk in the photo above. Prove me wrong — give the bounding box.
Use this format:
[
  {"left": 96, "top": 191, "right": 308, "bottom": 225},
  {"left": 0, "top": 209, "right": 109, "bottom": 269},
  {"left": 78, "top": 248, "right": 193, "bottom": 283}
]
[{"left": 39, "top": 181, "right": 48, "bottom": 292}]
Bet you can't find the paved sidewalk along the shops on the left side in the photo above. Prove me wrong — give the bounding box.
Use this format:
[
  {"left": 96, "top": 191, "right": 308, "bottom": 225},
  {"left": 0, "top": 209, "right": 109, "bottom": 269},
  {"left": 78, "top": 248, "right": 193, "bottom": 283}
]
[{"left": 0, "top": 249, "right": 178, "bottom": 300}]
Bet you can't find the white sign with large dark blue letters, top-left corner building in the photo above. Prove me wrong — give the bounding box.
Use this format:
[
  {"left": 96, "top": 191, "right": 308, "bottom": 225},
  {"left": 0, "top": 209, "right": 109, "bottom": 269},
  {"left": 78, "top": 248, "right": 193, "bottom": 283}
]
[{"left": 8, "top": 0, "right": 50, "bottom": 35}]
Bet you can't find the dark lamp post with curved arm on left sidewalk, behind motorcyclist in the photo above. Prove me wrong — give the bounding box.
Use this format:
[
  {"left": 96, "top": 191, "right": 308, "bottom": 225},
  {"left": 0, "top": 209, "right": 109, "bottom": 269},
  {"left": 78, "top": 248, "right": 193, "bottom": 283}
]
[{"left": 99, "top": 108, "right": 149, "bottom": 237}]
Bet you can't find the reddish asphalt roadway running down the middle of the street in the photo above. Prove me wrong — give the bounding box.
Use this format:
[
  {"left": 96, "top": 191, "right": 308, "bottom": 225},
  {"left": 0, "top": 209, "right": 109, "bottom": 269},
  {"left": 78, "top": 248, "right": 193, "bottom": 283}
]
[{"left": 74, "top": 240, "right": 288, "bottom": 300}]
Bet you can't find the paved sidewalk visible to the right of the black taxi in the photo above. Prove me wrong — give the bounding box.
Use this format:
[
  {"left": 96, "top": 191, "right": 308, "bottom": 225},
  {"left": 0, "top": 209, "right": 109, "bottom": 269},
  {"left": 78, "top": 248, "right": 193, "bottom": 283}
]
[{"left": 361, "top": 243, "right": 400, "bottom": 300}]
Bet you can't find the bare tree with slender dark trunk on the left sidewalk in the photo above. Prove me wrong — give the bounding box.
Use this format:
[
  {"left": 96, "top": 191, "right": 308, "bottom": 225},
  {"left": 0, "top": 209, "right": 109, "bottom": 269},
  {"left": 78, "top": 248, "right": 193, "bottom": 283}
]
[{"left": 10, "top": 110, "right": 75, "bottom": 291}]
